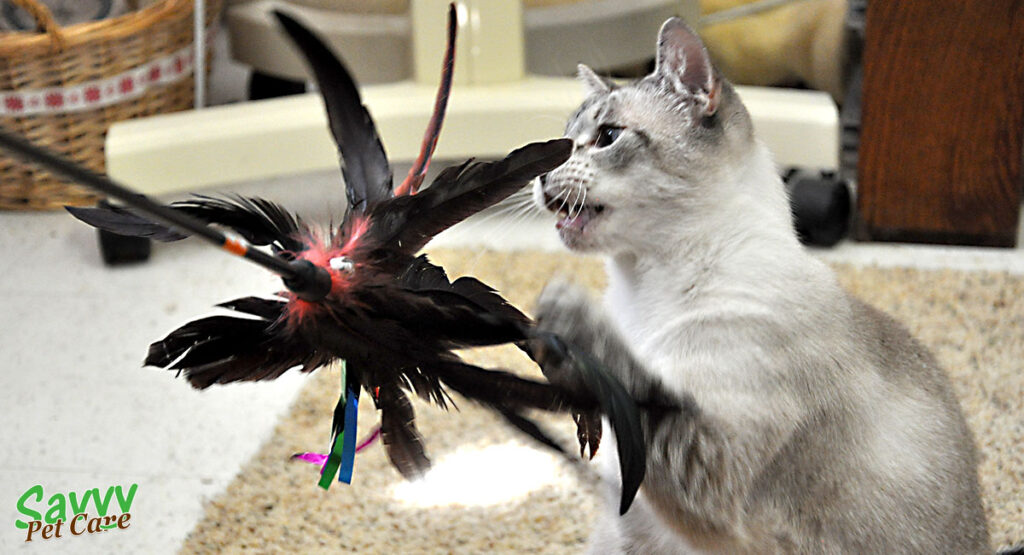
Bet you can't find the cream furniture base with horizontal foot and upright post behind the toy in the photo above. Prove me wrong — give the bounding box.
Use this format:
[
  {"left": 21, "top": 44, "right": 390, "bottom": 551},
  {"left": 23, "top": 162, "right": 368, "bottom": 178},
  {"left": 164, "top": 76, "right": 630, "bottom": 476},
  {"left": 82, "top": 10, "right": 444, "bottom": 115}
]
[{"left": 106, "top": 0, "right": 839, "bottom": 194}]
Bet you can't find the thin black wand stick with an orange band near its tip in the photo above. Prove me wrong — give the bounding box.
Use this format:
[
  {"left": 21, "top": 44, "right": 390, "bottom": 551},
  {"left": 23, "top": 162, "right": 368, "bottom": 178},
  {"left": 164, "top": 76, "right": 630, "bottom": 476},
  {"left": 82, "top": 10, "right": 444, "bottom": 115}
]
[{"left": 0, "top": 127, "right": 331, "bottom": 301}]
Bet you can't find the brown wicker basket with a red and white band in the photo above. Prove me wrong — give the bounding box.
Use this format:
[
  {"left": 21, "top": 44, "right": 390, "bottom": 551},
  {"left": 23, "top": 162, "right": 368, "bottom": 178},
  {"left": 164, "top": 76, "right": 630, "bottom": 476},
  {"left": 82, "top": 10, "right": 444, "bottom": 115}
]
[{"left": 0, "top": 0, "right": 222, "bottom": 210}]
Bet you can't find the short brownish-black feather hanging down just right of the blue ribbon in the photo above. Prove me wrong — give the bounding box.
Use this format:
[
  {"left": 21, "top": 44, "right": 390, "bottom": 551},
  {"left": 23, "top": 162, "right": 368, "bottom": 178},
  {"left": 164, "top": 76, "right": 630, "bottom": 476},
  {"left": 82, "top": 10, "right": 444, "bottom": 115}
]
[{"left": 377, "top": 384, "right": 430, "bottom": 479}]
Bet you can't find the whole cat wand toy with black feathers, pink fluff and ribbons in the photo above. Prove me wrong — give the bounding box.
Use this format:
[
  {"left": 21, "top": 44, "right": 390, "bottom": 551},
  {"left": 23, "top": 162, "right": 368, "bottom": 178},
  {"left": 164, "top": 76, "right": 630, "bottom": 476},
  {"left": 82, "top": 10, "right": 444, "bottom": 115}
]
[{"left": 0, "top": 7, "right": 646, "bottom": 512}]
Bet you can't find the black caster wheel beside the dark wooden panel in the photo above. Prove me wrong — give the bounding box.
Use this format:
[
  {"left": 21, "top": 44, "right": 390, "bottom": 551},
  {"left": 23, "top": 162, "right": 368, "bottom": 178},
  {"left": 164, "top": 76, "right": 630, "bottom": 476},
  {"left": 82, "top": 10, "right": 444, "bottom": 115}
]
[{"left": 785, "top": 170, "right": 852, "bottom": 247}]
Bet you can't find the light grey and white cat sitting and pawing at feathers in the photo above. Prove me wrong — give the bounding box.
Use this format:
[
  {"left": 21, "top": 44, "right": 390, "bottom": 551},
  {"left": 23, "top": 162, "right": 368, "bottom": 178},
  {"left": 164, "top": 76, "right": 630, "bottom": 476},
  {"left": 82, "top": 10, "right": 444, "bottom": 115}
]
[{"left": 534, "top": 18, "right": 989, "bottom": 553}]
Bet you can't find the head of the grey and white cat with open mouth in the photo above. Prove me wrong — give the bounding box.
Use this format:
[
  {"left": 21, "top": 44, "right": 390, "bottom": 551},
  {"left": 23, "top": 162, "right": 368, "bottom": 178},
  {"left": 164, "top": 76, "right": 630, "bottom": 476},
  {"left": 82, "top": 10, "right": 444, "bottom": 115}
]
[{"left": 534, "top": 17, "right": 754, "bottom": 254}]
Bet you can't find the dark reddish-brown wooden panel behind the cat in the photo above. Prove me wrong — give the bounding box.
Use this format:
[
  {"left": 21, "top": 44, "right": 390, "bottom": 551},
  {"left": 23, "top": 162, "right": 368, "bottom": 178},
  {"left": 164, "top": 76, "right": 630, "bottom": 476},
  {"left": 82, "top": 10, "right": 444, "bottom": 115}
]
[{"left": 856, "top": 0, "right": 1024, "bottom": 246}]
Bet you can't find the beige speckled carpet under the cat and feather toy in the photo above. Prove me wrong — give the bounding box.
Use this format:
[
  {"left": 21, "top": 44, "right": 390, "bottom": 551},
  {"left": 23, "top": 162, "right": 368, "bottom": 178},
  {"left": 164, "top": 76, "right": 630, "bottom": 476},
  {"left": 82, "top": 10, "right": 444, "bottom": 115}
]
[{"left": 183, "top": 251, "right": 1024, "bottom": 554}]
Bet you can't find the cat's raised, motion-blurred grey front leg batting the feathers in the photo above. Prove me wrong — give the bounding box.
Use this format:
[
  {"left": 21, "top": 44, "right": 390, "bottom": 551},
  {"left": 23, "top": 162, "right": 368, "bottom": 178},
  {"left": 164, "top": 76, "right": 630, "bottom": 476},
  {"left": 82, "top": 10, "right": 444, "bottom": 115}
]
[{"left": 537, "top": 283, "right": 792, "bottom": 552}]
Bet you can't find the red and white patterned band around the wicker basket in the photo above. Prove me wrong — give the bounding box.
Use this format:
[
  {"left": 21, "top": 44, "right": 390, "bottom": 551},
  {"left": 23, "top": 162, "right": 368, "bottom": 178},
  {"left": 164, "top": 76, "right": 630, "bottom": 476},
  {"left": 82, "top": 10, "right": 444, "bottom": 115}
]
[{"left": 0, "top": 46, "right": 195, "bottom": 116}]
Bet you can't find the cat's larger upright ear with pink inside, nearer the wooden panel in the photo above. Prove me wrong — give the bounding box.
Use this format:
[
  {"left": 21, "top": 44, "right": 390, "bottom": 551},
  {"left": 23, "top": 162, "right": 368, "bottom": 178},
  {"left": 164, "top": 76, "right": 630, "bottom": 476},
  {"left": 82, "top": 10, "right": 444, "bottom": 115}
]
[{"left": 654, "top": 17, "right": 722, "bottom": 116}]
